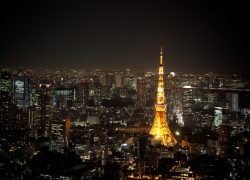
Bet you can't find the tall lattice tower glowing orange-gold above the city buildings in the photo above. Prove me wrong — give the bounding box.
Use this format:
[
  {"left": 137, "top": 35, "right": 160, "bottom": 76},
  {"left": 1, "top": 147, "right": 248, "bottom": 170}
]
[{"left": 150, "top": 46, "right": 177, "bottom": 146}]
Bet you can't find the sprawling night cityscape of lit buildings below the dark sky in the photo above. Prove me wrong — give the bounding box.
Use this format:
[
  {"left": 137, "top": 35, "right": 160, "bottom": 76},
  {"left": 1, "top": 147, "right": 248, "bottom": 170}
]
[{"left": 0, "top": 56, "right": 250, "bottom": 179}]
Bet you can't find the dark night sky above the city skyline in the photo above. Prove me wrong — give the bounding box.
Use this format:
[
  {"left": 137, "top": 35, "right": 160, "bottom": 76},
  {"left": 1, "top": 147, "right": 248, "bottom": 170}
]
[{"left": 0, "top": 0, "right": 250, "bottom": 71}]
